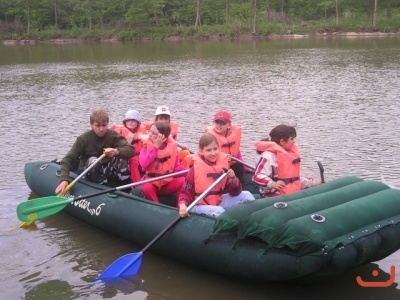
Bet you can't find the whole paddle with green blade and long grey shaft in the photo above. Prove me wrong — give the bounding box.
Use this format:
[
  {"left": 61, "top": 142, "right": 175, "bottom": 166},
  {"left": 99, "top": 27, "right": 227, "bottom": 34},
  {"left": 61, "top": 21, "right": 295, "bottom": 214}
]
[{"left": 17, "top": 170, "right": 189, "bottom": 221}]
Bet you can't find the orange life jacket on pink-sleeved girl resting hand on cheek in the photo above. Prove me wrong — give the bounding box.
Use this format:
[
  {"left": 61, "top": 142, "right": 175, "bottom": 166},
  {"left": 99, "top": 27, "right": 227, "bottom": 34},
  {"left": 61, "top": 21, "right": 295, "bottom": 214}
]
[{"left": 143, "top": 139, "right": 178, "bottom": 188}]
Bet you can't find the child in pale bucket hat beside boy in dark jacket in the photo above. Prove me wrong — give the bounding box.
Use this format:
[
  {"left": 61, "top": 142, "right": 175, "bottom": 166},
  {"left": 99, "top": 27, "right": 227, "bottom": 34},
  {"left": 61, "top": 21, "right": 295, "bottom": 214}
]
[{"left": 111, "top": 110, "right": 147, "bottom": 182}]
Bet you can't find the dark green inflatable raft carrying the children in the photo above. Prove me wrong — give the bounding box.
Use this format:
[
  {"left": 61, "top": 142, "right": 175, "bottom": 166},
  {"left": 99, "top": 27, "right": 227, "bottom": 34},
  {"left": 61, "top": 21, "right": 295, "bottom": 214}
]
[{"left": 24, "top": 161, "right": 400, "bottom": 283}]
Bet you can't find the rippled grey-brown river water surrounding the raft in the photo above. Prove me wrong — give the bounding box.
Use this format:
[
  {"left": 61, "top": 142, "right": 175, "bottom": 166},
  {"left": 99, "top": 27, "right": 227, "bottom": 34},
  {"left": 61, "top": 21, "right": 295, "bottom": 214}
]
[{"left": 0, "top": 38, "right": 400, "bottom": 299}]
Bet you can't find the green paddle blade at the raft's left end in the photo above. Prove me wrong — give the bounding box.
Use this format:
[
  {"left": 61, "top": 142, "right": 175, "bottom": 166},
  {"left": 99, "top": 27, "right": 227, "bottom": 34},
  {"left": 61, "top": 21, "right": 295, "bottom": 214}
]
[{"left": 17, "top": 196, "right": 73, "bottom": 222}]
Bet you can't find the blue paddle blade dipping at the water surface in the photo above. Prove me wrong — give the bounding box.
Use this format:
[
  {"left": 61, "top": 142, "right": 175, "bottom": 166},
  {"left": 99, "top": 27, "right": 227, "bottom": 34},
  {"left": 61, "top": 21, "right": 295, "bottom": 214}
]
[{"left": 97, "top": 252, "right": 143, "bottom": 281}]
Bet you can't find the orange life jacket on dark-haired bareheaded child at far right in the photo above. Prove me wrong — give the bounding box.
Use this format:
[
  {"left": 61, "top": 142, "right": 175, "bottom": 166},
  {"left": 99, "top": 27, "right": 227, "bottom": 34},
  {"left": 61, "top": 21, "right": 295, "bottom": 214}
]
[{"left": 254, "top": 141, "right": 301, "bottom": 195}]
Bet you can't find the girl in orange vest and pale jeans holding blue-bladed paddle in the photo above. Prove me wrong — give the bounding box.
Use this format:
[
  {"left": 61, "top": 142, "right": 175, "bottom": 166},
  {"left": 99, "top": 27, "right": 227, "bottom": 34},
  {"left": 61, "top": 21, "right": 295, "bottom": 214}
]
[{"left": 177, "top": 133, "right": 254, "bottom": 217}]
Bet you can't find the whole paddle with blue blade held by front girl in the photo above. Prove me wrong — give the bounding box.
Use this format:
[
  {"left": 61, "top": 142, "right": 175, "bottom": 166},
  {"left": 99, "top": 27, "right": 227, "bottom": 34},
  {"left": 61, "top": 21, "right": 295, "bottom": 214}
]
[{"left": 97, "top": 173, "right": 227, "bottom": 281}]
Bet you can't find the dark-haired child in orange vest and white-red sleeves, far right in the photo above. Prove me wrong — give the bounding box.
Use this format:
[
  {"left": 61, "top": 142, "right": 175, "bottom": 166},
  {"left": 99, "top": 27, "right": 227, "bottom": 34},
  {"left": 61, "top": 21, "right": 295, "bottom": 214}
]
[{"left": 252, "top": 125, "right": 321, "bottom": 198}]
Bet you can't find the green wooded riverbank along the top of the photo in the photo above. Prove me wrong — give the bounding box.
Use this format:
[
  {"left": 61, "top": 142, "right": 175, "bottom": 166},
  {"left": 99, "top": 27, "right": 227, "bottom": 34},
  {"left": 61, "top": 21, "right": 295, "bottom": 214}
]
[{"left": 0, "top": 0, "right": 400, "bottom": 41}]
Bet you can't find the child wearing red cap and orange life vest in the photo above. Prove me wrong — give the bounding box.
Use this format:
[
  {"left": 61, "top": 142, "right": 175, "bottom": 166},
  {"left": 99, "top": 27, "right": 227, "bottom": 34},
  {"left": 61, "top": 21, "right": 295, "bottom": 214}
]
[{"left": 205, "top": 110, "right": 248, "bottom": 180}]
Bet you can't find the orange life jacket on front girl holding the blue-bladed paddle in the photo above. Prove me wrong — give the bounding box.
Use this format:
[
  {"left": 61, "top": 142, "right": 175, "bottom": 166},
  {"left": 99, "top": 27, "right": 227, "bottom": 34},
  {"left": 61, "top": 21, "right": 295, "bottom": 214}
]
[{"left": 193, "top": 152, "right": 229, "bottom": 205}]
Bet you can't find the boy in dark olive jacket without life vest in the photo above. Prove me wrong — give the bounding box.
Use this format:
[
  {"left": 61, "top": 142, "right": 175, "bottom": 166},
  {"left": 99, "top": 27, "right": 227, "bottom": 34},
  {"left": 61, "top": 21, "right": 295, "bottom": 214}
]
[{"left": 55, "top": 109, "right": 135, "bottom": 194}]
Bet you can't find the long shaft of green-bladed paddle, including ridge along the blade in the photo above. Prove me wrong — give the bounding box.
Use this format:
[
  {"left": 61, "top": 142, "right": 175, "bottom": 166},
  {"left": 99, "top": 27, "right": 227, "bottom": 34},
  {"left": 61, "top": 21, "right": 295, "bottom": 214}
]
[{"left": 24, "top": 169, "right": 189, "bottom": 215}]
